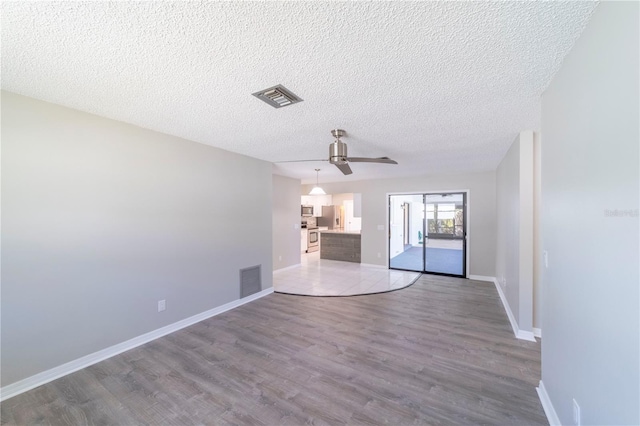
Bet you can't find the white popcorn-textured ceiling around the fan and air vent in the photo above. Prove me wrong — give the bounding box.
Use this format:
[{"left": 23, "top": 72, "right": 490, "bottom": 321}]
[{"left": 1, "top": 1, "right": 596, "bottom": 182}]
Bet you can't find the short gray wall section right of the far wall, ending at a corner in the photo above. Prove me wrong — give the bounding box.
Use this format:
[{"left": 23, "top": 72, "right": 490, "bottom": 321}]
[{"left": 496, "top": 130, "right": 534, "bottom": 332}]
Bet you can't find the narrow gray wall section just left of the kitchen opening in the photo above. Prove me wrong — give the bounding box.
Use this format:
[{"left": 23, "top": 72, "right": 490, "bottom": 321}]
[{"left": 272, "top": 175, "right": 301, "bottom": 271}]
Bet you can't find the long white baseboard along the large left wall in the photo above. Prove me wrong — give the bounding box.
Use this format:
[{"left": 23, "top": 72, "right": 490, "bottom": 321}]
[{"left": 0, "top": 287, "right": 273, "bottom": 401}]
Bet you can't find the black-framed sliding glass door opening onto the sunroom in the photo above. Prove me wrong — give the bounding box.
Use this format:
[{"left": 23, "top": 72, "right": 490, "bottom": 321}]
[{"left": 389, "top": 192, "right": 467, "bottom": 278}]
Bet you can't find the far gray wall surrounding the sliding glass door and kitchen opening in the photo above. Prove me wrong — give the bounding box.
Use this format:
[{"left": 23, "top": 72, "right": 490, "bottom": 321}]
[{"left": 301, "top": 171, "right": 496, "bottom": 277}]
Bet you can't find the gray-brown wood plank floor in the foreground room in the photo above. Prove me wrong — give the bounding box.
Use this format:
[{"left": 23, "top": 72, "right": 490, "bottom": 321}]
[{"left": 0, "top": 276, "right": 547, "bottom": 425}]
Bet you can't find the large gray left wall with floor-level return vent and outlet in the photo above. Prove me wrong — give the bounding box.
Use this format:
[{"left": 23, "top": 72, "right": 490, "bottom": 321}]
[{"left": 2, "top": 92, "right": 272, "bottom": 386}]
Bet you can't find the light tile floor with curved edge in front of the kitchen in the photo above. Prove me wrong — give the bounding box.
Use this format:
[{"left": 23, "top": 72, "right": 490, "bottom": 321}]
[{"left": 273, "top": 252, "right": 420, "bottom": 296}]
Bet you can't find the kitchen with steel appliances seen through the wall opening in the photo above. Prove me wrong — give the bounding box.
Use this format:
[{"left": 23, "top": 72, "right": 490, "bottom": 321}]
[{"left": 300, "top": 193, "right": 362, "bottom": 263}]
